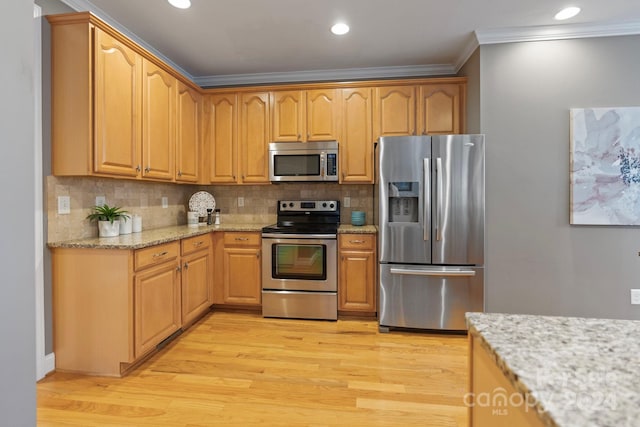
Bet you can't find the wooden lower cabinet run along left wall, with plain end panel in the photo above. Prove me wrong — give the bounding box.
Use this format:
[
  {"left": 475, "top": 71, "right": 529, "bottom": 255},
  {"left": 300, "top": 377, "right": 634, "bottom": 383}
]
[{"left": 51, "top": 234, "right": 212, "bottom": 376}]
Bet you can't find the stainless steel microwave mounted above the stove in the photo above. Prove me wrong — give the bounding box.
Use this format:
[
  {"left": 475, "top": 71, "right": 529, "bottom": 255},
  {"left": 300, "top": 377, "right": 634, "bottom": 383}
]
[{"left": 269, "top": 141, "right": 338, "bottom": 182}]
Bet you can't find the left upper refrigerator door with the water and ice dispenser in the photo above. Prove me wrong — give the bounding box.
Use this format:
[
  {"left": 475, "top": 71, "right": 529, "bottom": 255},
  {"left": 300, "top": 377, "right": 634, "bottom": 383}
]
[{"left": 378, "top": 136, "right": 433, "bottom": 264}]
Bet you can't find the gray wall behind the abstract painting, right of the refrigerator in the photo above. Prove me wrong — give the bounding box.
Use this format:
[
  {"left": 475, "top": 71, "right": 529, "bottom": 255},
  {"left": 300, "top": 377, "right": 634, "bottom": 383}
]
[{"left": 480, "top": 36, "right": 640, "bottom": 319}]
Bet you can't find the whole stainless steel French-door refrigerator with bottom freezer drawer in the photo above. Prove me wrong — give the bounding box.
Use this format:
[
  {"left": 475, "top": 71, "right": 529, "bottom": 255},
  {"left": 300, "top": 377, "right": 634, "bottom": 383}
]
[{"left": 376, "top": 135, "right": 485, "bottom": 331}]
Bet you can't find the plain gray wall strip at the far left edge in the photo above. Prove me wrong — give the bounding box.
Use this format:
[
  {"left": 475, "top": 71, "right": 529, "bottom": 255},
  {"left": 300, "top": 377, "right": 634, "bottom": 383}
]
[{"left": 0, "top": 0, "right": 36, "bottom": 426}]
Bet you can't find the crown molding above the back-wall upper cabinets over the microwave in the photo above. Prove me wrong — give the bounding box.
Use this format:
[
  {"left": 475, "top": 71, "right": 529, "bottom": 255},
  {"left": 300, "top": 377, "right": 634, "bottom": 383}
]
[{"left": 194, "top": 64, "right": 456, "bottom": 87}]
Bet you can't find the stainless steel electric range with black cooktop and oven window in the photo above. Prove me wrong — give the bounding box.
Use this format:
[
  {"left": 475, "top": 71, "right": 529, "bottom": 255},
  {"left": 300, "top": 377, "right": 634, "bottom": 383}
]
[{"left": 262, "top": 200, "right": 340, "bottom": 320}]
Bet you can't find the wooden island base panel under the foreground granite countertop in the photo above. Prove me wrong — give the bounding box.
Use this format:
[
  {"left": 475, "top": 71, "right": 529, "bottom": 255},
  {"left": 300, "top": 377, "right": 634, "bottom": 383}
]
[{"left": 464, "top": 334, "right": 545, "bottom": 427}]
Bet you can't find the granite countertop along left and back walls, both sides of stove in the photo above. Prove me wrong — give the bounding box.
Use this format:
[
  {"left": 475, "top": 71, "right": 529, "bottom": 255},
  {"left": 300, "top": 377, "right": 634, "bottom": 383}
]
[{"left": 47, "top": 223, "right": 377, "bottom": 249}]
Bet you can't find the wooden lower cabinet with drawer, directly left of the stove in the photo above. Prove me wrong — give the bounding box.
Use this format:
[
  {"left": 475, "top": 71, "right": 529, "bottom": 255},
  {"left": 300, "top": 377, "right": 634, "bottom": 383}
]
[{"left": 213, "top": 232, "right": 262, "bottom": 307}]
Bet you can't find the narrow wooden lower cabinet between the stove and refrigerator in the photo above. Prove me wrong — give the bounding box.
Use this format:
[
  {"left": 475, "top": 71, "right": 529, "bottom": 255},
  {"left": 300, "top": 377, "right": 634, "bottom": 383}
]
[{"left": 338, "top": 233, "right": 377, "bottom": 316}]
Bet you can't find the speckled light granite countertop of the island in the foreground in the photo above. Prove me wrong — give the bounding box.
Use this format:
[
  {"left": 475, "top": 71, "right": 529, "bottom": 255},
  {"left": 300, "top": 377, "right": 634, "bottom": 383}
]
[{"left": 467, "top": 313, "right": 640, "bottom": 427}]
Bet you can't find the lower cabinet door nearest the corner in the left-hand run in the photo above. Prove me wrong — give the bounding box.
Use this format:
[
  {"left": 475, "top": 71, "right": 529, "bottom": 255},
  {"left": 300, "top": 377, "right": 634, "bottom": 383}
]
[{"left": 182, "top": 250, "right": 213, "bottom": 325}]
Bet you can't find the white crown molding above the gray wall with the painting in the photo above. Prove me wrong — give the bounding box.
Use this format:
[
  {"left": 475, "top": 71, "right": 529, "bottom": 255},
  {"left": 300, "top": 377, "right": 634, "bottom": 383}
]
[{"left": 475, "top": 22, "right": 640, "bottom": 45}]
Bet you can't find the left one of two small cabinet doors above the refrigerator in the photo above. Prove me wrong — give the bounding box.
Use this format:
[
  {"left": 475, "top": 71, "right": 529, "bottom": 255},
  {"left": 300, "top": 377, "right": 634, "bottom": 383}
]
[{"left": 373, "top": 86, "right": 416, "bottom": 139}]
